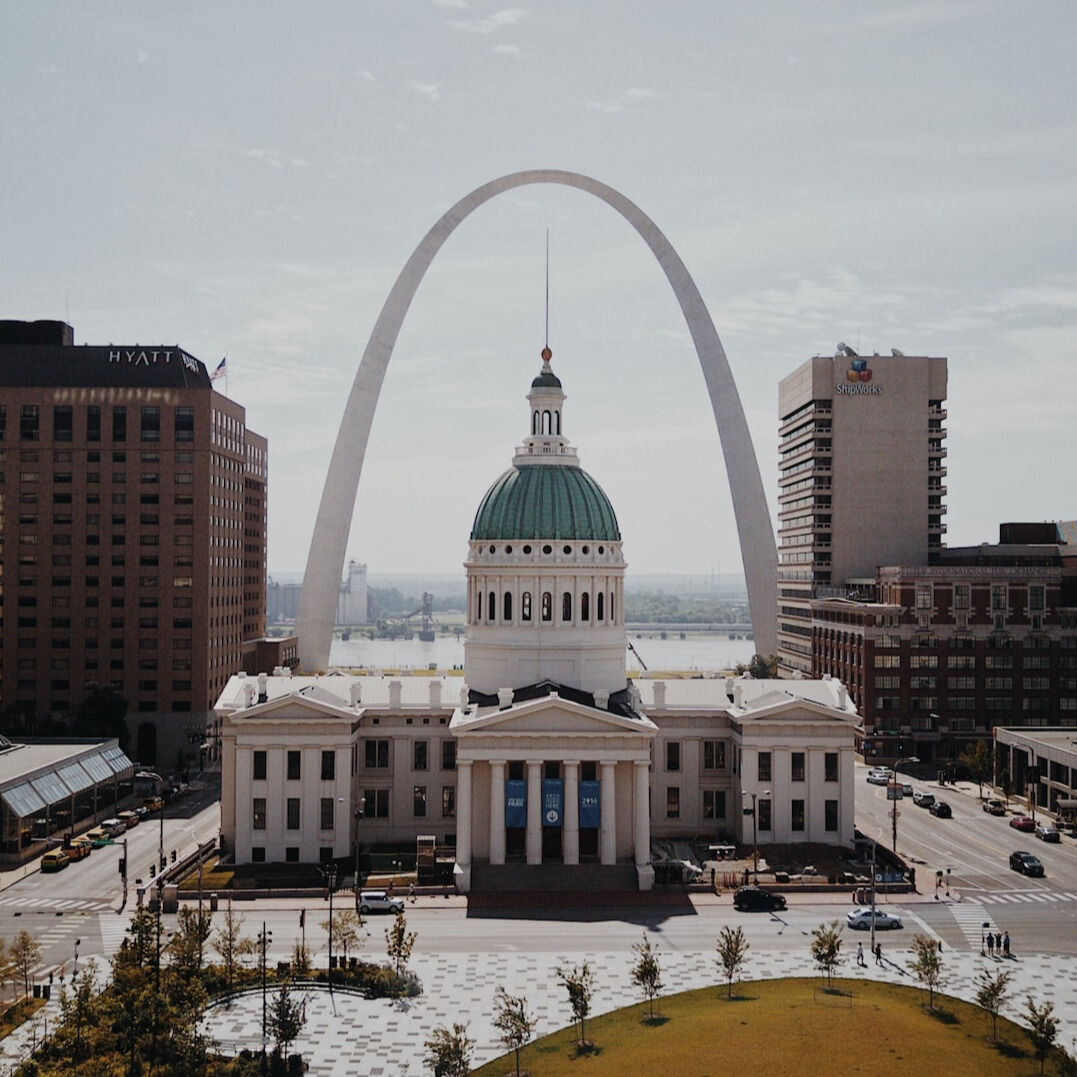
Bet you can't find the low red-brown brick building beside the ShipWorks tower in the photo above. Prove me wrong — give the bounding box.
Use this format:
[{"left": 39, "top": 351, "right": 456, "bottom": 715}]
[{"left": 811, "top": 523, "right": 1077, "bottom": 763}]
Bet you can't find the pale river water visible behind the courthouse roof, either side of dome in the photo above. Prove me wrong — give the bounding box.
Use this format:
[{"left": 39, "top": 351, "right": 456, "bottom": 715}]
[{"left": 330, "top": 631, "right": 755, "bottom": 672}]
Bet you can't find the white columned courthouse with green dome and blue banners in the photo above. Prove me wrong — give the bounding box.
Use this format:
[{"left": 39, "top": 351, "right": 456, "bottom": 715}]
[{"left": 216, "top": 350, "right": 856, "bottom": 891}]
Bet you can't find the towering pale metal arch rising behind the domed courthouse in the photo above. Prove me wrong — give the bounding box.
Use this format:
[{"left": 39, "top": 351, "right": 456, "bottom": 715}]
[{"left": 296, "top": 168, "right": 778, "bottom": 672}]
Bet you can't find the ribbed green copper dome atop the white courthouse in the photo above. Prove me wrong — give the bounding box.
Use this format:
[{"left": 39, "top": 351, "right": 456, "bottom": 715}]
[{"left": 471, "top": 464, "right": 620, "bottom": 542}]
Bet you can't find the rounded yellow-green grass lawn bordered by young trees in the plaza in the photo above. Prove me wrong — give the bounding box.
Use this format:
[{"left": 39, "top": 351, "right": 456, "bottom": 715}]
[{"left": 474, "top": 979, "right": 1053, "bottom": 1077}]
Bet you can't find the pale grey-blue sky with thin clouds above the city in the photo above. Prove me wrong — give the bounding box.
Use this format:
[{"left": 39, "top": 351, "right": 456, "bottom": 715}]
[{"left": 0, "top": 0, "right": 1077, "bottom": 574}]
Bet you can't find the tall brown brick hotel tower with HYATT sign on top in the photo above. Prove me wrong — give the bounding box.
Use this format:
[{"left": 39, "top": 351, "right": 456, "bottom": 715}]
[{"left": 0, "top": 321, "right": 267, "bottom": 772}]
